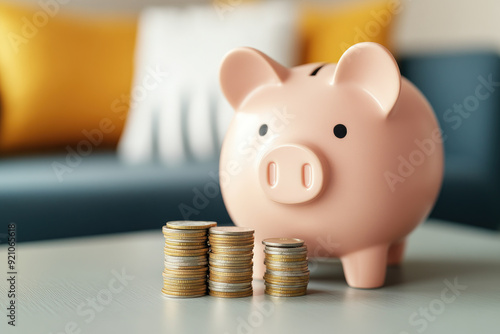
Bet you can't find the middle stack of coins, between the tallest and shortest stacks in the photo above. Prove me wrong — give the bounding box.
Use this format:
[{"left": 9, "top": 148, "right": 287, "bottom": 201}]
[{"left": 208, "top": 226, "right": 254, "bottom": 298}]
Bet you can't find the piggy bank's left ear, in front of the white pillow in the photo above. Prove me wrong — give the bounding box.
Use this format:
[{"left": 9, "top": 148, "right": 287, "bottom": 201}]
[{"left": 220, "top": 48, "right": 288, "bottom": 109}]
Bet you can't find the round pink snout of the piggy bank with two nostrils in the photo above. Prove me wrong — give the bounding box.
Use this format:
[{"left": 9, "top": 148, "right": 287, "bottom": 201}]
[{"left": 259, "top": 145, "right": 324, "bottom": 204}]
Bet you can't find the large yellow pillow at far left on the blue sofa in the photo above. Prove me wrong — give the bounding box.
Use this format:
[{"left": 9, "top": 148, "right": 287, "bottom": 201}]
[{"left": 0, "top": 4, "right": 137, "bottom": 154}]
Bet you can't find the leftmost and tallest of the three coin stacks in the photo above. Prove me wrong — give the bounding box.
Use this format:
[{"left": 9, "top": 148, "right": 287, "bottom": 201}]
[{"left": 162, "top": 221, "right": 217, "bottom": 298}]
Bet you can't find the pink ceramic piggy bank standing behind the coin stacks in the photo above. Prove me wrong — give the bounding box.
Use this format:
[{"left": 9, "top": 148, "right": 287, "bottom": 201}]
[{"left": 220, "top": 43, "right": 443, "bottom": 288}]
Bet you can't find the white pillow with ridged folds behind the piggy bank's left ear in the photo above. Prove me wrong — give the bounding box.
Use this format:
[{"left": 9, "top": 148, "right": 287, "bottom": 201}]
[{"left": 118, "top": 2, "right": 297, "bottom": 164}]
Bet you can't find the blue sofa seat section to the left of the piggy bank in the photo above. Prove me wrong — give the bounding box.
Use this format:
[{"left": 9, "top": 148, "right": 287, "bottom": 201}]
[{"left": 0, "top": 152, "right": 231, "bottom": 241}]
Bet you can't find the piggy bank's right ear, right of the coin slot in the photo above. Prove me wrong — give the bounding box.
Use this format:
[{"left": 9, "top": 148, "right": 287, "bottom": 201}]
[{"left": 332, "top": 42, "right": 401, "bottom": 116}]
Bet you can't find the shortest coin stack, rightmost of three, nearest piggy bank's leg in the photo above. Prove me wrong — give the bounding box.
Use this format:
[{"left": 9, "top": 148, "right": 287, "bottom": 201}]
[{"left": 262, "top": 238, "right": 309, "bottom": 297}]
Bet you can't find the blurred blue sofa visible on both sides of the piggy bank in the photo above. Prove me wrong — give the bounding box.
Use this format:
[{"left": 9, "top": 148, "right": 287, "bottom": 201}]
[{"left": 0, "top": 52, "right": 500, "bottom": 241}]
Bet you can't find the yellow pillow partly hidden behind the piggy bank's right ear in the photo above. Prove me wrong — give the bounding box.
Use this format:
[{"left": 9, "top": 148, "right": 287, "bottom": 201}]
[{"left": 299, "top": 0, "right": 402, "bottom": 63}]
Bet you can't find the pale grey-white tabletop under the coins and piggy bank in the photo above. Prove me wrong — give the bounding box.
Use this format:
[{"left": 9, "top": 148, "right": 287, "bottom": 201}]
[{"left": 0, "top": 222, "right": 500, "bottom": 334}]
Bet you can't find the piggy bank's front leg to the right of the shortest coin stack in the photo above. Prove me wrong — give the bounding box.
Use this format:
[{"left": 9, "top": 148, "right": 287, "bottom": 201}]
[{"left": 340, "top": 245, "right": 389, "bottom": 289}]
